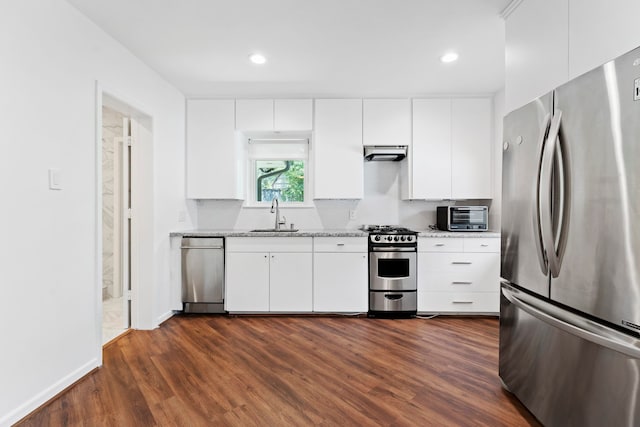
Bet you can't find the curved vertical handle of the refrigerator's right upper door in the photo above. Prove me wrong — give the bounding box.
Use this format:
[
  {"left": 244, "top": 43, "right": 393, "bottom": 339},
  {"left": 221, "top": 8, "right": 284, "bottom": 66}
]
[{"left": 539, "top": 110, "right": 562, "bottom": 277}]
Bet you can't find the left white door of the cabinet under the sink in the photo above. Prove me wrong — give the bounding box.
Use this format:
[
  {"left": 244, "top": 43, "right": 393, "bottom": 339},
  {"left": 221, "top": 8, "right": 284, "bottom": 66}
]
[{"left": 225, "top": 252, "right": 269, "bottom": 312}]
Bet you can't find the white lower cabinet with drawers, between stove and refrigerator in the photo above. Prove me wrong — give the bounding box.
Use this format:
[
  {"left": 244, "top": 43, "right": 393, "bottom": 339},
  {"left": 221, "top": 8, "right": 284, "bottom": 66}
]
[{"left": 418, "top": 237, "right": 500, "bottom": 313}]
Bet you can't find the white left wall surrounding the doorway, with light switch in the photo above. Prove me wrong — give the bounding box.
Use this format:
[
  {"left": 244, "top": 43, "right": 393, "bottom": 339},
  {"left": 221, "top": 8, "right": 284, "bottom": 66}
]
[{"left": 0, "top": 0, "right": 190, "bottom": 425}]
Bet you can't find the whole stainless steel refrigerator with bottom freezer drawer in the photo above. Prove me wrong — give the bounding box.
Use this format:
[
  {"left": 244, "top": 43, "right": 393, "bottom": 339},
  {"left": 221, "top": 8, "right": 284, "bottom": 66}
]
[{"left": 499, "top": 48, "right": 640, "bottom": 427}]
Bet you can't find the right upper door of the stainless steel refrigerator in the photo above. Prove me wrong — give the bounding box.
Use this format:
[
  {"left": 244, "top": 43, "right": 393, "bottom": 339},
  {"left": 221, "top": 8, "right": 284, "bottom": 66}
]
[{"left": 551, "top": 48, "right": 640, "bottom": 330}]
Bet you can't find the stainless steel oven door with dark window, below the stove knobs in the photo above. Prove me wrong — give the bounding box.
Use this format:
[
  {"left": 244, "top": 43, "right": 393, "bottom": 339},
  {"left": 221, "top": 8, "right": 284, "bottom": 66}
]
[{"left": 369, "top": 248, "right": 417, "bottom": 291}]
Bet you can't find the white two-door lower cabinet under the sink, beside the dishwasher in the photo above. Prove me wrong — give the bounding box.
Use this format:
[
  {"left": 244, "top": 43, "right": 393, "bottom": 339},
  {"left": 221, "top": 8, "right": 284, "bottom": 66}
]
[{"left": 225, "top": 237, "right": 313, "bottom": 313}]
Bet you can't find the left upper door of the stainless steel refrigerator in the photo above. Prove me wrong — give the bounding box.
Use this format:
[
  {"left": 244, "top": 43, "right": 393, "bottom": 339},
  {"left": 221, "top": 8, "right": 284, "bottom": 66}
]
[{"left": 500, "top": 94, "right": 552, "bottom": 297}]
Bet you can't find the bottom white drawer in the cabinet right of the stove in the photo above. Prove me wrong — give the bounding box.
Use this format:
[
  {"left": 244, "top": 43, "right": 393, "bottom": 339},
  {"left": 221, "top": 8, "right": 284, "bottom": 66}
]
[{"left": 418, "top": 291, "right": 500, "bottom": 313}]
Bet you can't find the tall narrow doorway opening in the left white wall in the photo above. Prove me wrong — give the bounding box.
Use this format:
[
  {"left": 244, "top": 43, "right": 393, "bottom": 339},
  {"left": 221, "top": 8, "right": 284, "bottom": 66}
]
[{"left": 101, "top": 103, "right": 132, "bottom": 345}]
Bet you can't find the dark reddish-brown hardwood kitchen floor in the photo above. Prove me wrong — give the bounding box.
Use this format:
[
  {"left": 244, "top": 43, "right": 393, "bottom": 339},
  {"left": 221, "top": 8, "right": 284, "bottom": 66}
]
[{"left": 18, "top": 315, "right": 539, "bottom": 427}]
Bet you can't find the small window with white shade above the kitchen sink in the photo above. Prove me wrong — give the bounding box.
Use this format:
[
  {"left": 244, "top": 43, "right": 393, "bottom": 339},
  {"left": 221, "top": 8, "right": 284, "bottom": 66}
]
[{"left": 248, "top": 139, "right": 310, "bottom": 206}]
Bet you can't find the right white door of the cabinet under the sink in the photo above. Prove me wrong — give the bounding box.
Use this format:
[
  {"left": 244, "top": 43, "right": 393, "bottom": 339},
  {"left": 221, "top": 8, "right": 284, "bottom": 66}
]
[{"left": 268, "top": 252, "right": 313, "bottom": 312}]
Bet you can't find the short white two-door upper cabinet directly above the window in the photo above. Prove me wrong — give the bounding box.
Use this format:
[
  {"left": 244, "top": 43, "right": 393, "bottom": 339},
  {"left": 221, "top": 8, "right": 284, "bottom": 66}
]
[{"left": 236, "top": 99, "right": 313, "bottom": 131}]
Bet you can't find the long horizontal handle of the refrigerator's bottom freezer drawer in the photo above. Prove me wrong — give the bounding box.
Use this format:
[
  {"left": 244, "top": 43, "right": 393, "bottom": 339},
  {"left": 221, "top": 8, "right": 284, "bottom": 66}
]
[{"left": 501, "top": 283, "right": 640, "bottom": 359}]
